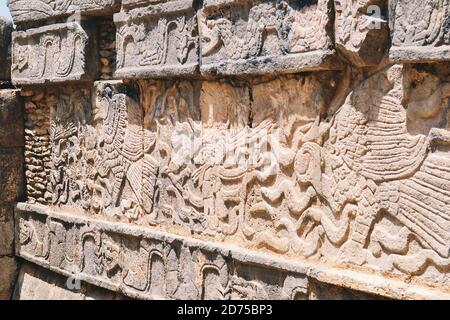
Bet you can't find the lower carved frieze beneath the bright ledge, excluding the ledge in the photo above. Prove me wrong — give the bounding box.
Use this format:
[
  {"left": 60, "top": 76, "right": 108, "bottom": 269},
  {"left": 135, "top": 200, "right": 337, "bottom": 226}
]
[{"left": 16, "top": 206, "right": 320, "bottom": 300}]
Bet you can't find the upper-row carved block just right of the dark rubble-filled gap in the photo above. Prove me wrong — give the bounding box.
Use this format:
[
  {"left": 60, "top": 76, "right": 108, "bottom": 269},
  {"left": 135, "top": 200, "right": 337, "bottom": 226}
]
[{"left": 114, "top": 0, "right": 199, "bottom": 78}]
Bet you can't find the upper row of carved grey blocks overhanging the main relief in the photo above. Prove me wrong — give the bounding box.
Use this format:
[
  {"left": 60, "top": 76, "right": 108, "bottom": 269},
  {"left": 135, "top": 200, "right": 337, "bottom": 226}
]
[{"left": 9, "top": 0, "right": 450, "bottom": 84}]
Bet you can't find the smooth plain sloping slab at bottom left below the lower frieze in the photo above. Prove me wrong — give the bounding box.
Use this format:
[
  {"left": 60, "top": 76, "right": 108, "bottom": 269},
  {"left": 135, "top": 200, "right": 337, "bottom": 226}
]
[{"left": 13, "top": 263, "right": 124, "bottom": 300}]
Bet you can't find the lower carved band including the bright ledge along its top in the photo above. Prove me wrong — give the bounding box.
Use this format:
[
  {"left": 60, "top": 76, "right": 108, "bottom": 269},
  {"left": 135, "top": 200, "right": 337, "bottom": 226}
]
[{"left": 16, "top": 204, "right": 450, "bottom": 300}]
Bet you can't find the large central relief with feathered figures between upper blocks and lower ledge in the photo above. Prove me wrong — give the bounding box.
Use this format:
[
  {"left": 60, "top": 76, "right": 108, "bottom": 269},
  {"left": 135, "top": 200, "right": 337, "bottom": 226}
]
[{"left": 20, "top": 65, "right": 450, "bottom": 298}]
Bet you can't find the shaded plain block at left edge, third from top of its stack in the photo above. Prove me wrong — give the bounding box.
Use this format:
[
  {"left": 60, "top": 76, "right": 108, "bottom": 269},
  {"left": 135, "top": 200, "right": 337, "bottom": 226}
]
[{"left": 0, "top": 148, "right": 23, "bottom": 204}]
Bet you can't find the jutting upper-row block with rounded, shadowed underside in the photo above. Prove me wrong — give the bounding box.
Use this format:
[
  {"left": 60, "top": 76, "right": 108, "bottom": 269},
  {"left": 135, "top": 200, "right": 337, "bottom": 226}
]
[{"left": 334, "top": 0, "right": 389, "bottom": 67}]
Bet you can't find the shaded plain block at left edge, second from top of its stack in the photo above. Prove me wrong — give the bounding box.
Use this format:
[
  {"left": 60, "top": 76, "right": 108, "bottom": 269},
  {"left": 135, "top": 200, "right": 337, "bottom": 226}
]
[{"left": 0, "top": 90, "right": 24, "bottom": 147}]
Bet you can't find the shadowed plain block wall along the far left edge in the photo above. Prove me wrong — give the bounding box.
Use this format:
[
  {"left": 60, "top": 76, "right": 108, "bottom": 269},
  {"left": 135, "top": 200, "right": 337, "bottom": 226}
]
[{"left": 0, "top": 18, "right": 20, "bottom": 300}]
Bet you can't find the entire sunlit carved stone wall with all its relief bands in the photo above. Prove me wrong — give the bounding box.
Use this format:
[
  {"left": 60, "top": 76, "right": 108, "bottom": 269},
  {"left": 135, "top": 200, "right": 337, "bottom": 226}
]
[{"left": 0, "top": 0, "right": 450, "bottom": 299}]
